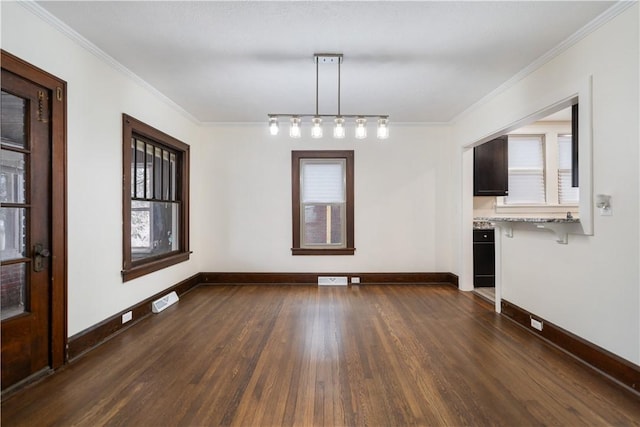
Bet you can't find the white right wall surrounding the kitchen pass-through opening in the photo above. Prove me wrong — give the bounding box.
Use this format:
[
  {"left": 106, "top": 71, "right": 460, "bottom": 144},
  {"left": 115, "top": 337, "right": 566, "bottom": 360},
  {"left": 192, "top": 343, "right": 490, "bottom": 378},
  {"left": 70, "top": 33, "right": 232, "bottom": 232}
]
[{"left": 453, "top": 3, "right": 640, "bottom": 364}]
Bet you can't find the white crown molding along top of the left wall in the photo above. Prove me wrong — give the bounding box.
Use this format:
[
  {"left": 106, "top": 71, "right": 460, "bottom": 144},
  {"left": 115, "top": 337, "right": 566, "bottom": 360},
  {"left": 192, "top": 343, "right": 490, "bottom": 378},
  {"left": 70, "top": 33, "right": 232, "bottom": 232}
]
[{"left": 17, "top": 0, "right": 201, "bottom": 125}]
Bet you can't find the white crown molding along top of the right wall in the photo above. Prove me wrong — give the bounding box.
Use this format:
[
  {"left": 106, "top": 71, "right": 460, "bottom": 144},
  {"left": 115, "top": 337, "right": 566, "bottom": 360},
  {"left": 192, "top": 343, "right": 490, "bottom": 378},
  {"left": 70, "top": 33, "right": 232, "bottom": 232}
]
[{"left": 449, "top": 0, "right": 638, "bottom": 125}]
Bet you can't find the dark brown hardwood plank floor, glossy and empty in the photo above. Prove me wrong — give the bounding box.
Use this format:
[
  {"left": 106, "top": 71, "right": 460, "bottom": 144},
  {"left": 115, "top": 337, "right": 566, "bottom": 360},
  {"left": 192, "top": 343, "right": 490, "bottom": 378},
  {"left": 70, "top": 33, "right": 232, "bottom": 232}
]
[{"left": 2, "top": 285, "right": 640, "bottom": 426}]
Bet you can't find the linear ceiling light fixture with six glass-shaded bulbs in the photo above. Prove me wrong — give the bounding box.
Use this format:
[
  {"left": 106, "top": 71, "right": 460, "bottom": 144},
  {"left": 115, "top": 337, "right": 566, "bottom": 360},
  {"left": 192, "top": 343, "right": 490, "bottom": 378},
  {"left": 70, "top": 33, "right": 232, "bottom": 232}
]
[{"left": 268, "top": 53, "right": 389, "bottom": 139}]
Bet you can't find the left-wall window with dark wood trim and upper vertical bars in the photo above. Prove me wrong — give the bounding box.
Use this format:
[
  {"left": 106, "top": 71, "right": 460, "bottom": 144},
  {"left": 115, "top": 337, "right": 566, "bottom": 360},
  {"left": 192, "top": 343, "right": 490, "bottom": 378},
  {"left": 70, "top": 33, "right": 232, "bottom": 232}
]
[{"left": 122, "top": 114, "right": 189, "bottom": 282}]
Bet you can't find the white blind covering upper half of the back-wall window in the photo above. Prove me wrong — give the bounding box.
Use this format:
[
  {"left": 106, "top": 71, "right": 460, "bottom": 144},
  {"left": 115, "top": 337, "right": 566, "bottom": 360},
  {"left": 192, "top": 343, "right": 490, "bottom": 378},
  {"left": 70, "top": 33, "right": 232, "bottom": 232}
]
[{"left": 302, "top": 159, "right": 346, "bottom": 203}]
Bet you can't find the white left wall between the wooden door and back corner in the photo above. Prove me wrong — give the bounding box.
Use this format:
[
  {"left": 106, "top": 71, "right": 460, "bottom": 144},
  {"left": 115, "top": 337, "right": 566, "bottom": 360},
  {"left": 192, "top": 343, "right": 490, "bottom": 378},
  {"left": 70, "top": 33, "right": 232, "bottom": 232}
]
[{"left": 2, "top": 2, "right": 203, "bottom": 336}]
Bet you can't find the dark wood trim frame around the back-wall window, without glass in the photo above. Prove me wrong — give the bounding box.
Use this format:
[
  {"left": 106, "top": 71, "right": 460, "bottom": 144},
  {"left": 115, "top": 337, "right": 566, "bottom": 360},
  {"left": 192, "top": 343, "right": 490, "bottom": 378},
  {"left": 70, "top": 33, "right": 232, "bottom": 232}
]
[{"left": 291, "top": 150, "right": 356, "bottom": 255}]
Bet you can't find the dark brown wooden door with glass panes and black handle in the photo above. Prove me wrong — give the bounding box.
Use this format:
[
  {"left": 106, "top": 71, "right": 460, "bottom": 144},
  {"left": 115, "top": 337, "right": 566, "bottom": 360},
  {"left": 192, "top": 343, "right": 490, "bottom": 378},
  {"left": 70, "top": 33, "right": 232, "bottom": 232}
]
[{"left": 0, "top": 52, "right": 66, "bottom": 390}]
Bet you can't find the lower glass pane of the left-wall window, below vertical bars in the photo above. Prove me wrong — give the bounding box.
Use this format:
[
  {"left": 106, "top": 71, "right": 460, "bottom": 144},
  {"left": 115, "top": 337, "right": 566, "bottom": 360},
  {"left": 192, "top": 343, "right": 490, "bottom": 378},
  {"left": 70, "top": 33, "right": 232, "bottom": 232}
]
[{"left": 131, "top": 201, "right": 180, "bottom": 261}]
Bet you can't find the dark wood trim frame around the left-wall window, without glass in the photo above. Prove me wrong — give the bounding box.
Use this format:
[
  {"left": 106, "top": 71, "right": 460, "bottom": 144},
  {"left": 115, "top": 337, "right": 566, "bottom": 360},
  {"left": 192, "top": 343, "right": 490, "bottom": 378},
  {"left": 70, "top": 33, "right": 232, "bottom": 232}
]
[{"left": 122, "top": 114, "right": 190, "bottom": 282}]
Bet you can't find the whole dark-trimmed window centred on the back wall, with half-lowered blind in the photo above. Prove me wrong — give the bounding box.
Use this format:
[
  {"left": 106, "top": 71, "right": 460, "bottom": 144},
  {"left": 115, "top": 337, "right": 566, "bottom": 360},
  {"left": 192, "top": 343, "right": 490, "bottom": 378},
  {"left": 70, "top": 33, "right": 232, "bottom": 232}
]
[{"left": 291, "top": 151, "right": 355, "bottom": 255}]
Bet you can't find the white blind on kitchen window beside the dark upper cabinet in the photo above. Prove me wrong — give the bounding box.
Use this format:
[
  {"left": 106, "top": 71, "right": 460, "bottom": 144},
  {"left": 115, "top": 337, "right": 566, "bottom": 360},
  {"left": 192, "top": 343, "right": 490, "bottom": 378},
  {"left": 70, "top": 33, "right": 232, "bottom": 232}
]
[{"left": 505, "top": 135, "right": 546, "bottom": 204}]
